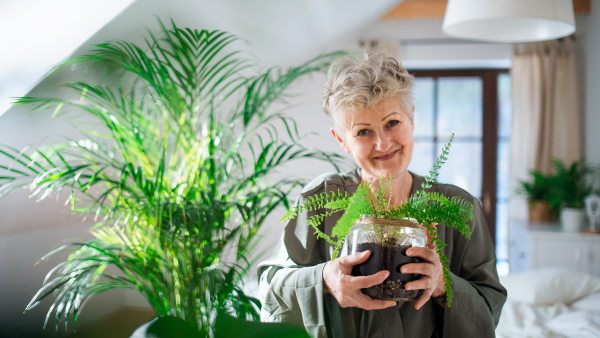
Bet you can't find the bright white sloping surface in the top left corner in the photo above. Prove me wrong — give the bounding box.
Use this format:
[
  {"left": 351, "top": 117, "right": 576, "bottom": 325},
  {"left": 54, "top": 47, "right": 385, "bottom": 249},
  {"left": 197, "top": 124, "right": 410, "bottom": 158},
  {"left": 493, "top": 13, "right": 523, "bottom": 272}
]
[{"left": 0, "top": 0, "right": 133, "bottom": 115}]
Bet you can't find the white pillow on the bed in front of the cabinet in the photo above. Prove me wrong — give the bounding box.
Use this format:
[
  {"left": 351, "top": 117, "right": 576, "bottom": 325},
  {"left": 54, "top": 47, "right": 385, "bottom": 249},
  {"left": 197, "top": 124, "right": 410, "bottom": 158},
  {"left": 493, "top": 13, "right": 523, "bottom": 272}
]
[{"left": 500, "top": 268, "right": 600, "bottom": 305}]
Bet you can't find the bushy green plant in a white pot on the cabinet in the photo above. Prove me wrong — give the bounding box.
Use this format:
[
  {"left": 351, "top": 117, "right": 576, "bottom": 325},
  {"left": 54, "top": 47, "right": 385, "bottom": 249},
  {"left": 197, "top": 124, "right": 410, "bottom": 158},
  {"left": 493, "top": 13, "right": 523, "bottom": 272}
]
[{"left": 551, "top": 159, "right": 595, "bottom": 232}]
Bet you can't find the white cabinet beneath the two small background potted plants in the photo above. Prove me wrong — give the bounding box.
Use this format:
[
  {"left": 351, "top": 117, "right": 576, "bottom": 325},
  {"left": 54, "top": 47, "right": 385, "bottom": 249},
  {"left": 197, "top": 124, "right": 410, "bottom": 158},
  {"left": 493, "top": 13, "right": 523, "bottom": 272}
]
[{"left": 509, "top": 222, "right": 600, "bottom": 276}]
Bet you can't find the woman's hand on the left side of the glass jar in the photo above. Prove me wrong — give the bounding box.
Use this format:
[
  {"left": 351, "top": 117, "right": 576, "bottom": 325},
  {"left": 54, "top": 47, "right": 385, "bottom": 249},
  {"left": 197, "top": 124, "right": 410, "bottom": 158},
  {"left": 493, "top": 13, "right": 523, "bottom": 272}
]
[{"left": 323, "top": 250, "right": 396, "bottom": 310}]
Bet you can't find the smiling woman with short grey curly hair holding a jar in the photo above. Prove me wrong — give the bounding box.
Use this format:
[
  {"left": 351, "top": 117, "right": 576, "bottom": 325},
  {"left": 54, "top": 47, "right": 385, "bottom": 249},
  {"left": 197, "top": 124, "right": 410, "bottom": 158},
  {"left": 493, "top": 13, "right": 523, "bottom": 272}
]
[{"left": 258, "top": 53, "right": 506, "bottom": 338}]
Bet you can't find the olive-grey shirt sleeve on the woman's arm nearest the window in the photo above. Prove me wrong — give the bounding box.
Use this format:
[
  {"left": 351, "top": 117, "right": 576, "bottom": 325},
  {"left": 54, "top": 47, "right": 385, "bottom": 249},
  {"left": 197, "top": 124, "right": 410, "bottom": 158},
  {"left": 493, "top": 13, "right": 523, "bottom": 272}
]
[{"left": 443, "top": 198, "right": 507, "bottom": 337}]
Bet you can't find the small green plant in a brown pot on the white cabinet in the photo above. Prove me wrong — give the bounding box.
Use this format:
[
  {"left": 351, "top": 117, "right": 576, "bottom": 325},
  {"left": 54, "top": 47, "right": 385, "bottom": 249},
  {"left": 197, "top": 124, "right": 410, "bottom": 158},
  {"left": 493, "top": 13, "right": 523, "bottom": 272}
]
[{"left": 517, "top": 170, "right": 559, "bottom": 223}]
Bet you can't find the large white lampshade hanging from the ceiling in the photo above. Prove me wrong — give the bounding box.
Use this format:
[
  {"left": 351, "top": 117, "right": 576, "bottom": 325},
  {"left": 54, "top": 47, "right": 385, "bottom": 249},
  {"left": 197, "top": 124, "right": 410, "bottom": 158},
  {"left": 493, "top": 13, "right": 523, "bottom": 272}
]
[{"left": 442, "top": 0, "right": 575, "bottom": 42}]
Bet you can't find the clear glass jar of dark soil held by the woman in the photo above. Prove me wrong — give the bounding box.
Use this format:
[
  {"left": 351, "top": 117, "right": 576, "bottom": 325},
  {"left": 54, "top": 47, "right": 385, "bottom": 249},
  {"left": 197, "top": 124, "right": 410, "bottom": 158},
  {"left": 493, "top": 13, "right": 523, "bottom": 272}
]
[{"left": 347, "top": 215, "right": 426, "bottom": 301}]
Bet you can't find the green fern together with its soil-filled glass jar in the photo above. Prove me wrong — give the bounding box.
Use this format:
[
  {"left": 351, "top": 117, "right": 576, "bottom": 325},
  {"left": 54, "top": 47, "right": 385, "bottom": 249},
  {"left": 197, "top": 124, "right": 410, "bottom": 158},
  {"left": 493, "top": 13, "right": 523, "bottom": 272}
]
[{"left": 281, "top": 135, "right": 473, "bottom": 306}]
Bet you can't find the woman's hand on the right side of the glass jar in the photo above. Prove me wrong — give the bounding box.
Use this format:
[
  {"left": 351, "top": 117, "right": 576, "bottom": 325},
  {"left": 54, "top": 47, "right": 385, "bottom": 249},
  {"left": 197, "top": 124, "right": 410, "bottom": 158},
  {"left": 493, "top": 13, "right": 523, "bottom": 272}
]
[{"left": 401, "top": 228, "right": 446, "bottom": 310}]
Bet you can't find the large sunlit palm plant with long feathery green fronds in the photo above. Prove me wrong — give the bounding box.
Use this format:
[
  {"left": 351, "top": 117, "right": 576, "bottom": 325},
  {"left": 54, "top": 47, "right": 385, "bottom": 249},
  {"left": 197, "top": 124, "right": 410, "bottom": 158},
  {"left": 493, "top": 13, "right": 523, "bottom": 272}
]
[{"left": 0, "top": 22, "right": 341, "bottom": 336}]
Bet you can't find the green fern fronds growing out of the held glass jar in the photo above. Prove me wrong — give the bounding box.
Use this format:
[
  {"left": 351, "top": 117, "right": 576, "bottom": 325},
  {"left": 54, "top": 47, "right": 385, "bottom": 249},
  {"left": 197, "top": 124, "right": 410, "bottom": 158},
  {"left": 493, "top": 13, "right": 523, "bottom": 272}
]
[{"left": 280, "top": 134, "right": 473, "bottom": 307}]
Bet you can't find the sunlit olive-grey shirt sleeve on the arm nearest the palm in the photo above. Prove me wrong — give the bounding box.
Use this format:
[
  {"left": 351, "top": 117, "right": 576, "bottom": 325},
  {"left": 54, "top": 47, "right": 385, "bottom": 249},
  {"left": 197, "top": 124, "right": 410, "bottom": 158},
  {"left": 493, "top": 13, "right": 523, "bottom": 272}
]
[{"left": 258, "top": 191, "right": 327, "bottom": 337}]
